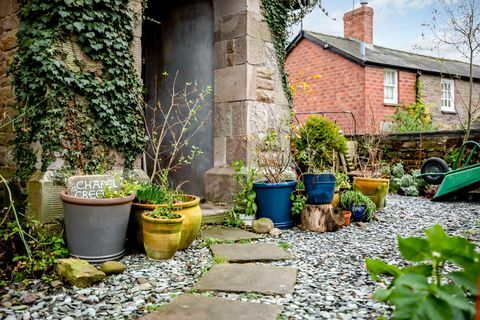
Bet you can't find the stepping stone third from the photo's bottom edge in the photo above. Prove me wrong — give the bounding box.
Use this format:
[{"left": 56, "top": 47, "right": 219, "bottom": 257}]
[{"left": 210, "top": 243, "right": 292, "bottom": 263}]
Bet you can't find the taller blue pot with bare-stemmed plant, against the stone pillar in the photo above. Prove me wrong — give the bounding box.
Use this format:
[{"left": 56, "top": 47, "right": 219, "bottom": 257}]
[{"left": 253, "top": 126, "right": 297, "bottom": 228}]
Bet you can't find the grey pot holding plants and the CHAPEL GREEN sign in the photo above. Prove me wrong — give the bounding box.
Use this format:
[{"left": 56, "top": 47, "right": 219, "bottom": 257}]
[{"left": 60, "top": 175, "right": 136, "bottom": 263}]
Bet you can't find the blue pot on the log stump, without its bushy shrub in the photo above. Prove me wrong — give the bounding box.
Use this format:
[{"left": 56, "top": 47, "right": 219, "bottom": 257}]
[{"left": 303, "top": 173, "right": 335, "bottom": 204}]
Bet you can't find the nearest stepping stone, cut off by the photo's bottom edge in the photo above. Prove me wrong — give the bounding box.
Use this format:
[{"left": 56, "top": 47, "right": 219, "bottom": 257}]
[{"left": 140, "top": 295, "right": 283, "bottom": 320}]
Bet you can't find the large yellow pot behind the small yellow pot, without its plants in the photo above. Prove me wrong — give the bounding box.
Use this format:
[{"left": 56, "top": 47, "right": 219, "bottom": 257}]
[{"left": 129, "top": 196, "right": 202, "bottom": 250}]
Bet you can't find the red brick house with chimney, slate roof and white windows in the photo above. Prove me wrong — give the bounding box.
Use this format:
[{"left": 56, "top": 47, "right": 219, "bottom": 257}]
[{"left": 286, "top": 2, "right": 480, "bottom": 134}]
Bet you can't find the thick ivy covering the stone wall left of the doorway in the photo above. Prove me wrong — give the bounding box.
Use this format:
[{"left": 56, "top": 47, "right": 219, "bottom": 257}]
[{"left": 9, "top": 0, "right": 146, "bottom": 179}]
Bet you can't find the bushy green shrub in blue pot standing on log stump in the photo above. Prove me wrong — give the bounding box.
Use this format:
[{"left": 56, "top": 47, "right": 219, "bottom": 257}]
[{"left": 293, "top": 116, "right": 346, "bottom": 204}]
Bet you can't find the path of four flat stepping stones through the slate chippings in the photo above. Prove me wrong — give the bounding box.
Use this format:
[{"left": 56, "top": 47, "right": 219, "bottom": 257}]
[{"left": 142, "top": 228, "right": 297, "bottom": 320}]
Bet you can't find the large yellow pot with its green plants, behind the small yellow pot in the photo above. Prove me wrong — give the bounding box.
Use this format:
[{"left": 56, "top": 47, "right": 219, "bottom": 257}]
[{"left": 129, "top": 183, "right": 202, "bottom": 250}]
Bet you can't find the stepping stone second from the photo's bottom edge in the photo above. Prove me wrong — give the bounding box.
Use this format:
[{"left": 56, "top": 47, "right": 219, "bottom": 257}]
[{"left": 195, "top": 263, "right": 297, "bottom": 294}]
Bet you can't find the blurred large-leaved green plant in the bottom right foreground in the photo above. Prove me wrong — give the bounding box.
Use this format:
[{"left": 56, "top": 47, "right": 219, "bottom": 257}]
[{"left": 366, "top": 225, "right": 480, "bottom": 320}]
